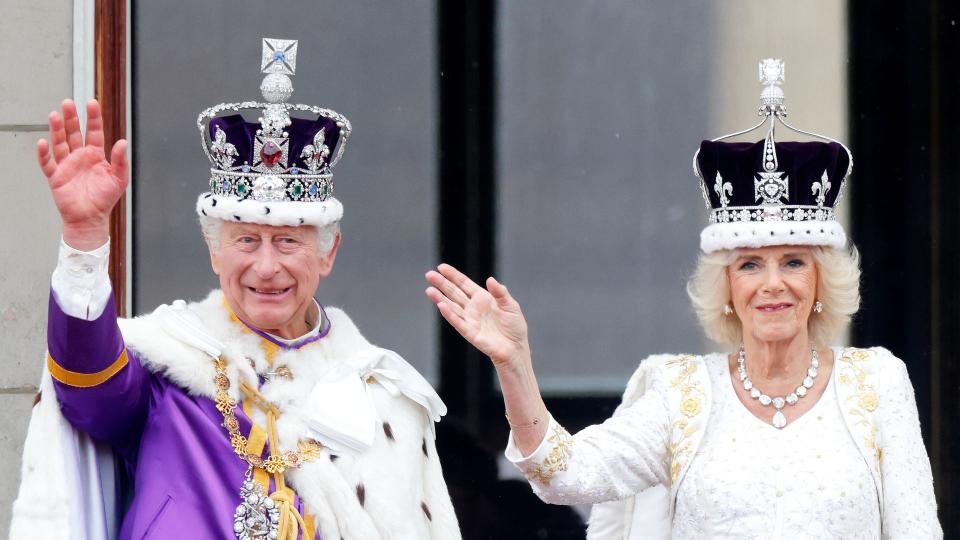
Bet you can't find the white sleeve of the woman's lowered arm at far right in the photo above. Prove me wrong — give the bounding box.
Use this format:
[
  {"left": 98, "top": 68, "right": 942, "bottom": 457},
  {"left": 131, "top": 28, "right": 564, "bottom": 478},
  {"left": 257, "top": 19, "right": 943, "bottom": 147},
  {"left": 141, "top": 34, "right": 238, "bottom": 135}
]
[{"left": 878, "top": 351, "right": 943, "bottom": 540}]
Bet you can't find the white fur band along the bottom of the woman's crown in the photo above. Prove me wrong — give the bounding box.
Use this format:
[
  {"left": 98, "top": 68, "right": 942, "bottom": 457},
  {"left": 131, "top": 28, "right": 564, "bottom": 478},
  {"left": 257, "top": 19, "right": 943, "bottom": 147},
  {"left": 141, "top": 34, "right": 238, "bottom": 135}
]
[{"left": 700, "top": 221, "right": 847, "bottom": 253}]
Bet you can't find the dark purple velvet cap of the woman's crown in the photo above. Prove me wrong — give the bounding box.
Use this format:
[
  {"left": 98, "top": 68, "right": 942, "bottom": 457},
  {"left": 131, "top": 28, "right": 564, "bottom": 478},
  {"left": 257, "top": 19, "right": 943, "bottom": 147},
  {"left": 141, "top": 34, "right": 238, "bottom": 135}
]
[{"left": 697, "top": 141, "right": 850, "bottom": 209}]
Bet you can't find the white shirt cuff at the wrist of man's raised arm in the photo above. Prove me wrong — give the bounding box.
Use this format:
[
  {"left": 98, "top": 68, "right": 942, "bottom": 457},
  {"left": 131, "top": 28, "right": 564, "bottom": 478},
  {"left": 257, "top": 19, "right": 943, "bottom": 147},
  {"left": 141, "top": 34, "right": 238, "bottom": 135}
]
[{"left": 50, "top": 239, "right": 111, "bottom": 321}]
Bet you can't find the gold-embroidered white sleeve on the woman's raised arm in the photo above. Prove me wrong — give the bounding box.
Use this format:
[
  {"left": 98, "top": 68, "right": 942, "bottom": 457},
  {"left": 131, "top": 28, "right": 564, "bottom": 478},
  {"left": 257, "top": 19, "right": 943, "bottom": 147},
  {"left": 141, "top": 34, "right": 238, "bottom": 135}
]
[{"left": 505, "top": 368, "right": 670, "bottom": 504}]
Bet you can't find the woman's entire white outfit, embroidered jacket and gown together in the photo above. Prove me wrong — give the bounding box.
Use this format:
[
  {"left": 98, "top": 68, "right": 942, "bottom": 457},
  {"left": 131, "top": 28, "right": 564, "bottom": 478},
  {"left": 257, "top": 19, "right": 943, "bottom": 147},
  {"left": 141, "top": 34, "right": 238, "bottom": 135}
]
[{"left": 506, "top": 348, "right": 943, "bottom": 540}]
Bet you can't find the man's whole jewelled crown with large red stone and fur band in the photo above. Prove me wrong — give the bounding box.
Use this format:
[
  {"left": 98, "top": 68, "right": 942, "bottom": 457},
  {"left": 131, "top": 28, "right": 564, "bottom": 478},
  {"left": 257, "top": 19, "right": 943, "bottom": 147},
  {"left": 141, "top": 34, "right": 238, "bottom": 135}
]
[{"left": 197, "top": 38, "right": 351, "bottom": 225}]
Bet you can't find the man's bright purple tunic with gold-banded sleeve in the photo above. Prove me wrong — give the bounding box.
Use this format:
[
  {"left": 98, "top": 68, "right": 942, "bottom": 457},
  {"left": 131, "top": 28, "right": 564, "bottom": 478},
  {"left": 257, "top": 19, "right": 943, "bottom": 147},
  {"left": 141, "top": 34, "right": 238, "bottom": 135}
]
[{"left": 47, "top": 294, "right": 319, "bottom": 540}]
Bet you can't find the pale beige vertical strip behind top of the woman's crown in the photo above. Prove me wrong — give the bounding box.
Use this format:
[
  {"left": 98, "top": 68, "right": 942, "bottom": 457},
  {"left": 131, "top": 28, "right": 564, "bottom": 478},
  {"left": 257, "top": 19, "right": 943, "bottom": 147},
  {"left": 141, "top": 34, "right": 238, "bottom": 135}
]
[{"left": 708, "top": 0, "right": 848, "bottom": 142}]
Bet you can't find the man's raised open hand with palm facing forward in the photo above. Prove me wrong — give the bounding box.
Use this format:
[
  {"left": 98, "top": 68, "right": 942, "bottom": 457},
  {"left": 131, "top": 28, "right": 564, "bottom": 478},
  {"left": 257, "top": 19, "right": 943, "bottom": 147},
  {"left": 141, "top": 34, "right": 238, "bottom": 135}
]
[{"left": 37, "top": 99, "right": 128, "bottom": 251}]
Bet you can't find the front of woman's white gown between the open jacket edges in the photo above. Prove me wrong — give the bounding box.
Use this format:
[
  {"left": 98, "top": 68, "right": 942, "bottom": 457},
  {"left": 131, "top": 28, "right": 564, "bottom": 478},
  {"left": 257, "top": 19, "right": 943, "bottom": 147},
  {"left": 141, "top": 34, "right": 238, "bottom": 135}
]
[{"left": 673, "top": 356, "right": 880, "bottom": 540}]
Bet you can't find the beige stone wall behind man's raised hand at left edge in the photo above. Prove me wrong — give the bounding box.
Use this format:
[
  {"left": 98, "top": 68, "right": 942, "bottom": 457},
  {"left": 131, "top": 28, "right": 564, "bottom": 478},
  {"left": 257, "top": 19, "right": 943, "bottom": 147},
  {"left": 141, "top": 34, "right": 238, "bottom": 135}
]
[{"left": 0, "top": 0, "right": 74, "bottom": 538}]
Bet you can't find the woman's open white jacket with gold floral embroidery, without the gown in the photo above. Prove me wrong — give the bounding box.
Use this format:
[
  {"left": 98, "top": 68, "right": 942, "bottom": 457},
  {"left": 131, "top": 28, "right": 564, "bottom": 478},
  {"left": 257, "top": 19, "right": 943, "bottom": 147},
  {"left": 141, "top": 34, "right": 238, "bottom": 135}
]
[{"left": 507, "top": 347, "right": 943, "bottom": 540}]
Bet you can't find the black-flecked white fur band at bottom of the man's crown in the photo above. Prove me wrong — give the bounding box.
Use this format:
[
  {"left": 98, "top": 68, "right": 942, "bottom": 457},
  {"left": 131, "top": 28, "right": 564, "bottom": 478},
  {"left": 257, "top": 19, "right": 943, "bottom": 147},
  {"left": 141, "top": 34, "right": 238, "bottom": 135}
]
[{"left": 197, "top": 192, "right": 343, "bottom": 227}]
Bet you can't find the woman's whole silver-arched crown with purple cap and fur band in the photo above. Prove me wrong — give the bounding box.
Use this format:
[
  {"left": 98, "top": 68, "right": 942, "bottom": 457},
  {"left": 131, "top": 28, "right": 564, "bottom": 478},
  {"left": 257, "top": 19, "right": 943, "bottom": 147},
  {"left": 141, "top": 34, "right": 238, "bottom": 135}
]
[{"left": 694, "top": 58, "right": 853, "bottom": 252}]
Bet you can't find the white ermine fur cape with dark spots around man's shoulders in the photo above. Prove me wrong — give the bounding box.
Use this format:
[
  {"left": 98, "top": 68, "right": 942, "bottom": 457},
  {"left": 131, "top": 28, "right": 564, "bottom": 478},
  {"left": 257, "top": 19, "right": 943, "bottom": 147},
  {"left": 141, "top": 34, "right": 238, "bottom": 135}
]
[{"left": 120, "top": 291, "right": 460, "bottom": 540}]
